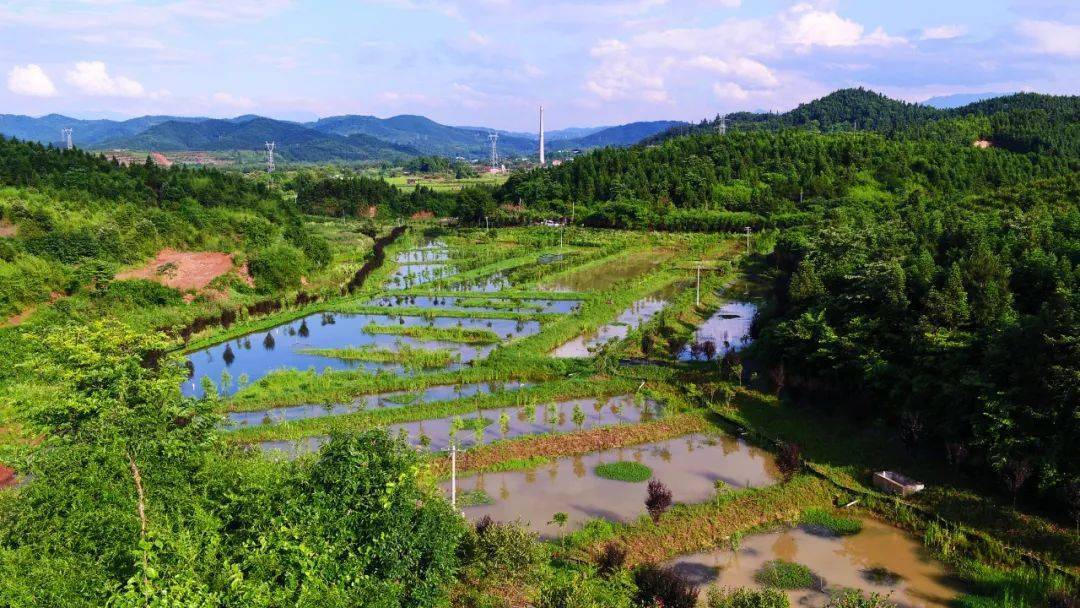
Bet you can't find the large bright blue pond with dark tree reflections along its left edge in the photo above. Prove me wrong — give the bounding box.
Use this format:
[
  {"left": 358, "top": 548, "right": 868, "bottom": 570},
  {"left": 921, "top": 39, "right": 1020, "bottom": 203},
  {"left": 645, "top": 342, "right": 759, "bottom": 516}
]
[{"left": 181, "top": 313, "right": 540, "bottom": 396}]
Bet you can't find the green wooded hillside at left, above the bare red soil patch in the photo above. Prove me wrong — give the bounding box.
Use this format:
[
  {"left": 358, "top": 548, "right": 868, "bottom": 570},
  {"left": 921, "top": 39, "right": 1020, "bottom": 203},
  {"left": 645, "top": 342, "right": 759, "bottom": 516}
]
[{"left": 0, "top": 138, "right": 329, "bottom": 315}]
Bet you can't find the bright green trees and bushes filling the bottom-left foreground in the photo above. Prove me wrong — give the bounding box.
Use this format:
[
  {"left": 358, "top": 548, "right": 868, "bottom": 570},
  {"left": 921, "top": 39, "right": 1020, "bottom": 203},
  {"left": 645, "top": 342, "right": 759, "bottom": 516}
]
[{"left": 0, "top": 324, "right": 463, "bottom": 607}]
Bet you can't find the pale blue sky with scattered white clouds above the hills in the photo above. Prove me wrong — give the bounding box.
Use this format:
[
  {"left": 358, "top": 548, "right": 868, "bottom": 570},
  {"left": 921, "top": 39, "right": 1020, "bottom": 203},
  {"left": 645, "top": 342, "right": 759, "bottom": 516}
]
[{"left": 0, "top": 0, "right": 1080, "bottom": 130}]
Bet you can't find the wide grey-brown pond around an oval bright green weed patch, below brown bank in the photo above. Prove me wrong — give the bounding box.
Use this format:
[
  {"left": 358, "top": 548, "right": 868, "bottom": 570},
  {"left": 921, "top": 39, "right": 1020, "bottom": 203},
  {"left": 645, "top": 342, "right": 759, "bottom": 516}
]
[{"left": 443, "top": 435, "right": 778, "bottom": 536}]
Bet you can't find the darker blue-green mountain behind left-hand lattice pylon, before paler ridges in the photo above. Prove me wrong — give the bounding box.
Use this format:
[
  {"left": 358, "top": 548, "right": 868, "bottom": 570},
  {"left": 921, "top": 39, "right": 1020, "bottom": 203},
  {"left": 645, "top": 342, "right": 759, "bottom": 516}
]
[{"left": 100, "top": 117, "right": 418, "bottom": 162}]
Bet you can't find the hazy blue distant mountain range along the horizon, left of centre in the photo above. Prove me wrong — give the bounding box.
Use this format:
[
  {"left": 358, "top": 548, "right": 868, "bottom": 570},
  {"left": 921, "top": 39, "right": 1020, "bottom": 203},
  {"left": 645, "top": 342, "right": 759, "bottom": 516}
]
[{"left": 0, "top": 109, "right": 685, "bottom": 162}]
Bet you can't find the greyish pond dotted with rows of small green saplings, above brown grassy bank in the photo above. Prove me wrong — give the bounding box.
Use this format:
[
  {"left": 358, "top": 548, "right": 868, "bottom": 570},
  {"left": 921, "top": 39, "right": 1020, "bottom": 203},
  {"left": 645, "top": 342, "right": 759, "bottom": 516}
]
[{"left": 259, "top": 395, "right": 661, "bottom": 455}]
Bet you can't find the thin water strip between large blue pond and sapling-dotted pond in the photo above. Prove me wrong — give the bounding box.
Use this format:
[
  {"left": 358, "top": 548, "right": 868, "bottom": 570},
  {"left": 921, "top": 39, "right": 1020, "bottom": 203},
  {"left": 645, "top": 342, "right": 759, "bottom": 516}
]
[{"left": 225, "top": 380, "right": 531, "bottom": 430}]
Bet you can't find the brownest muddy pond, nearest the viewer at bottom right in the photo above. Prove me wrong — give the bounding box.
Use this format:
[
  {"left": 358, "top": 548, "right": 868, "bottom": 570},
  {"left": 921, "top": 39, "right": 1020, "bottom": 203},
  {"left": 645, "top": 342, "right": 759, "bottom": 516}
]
[{"left": 669, "top": 518, "right": 960, "bottom": 608}]
